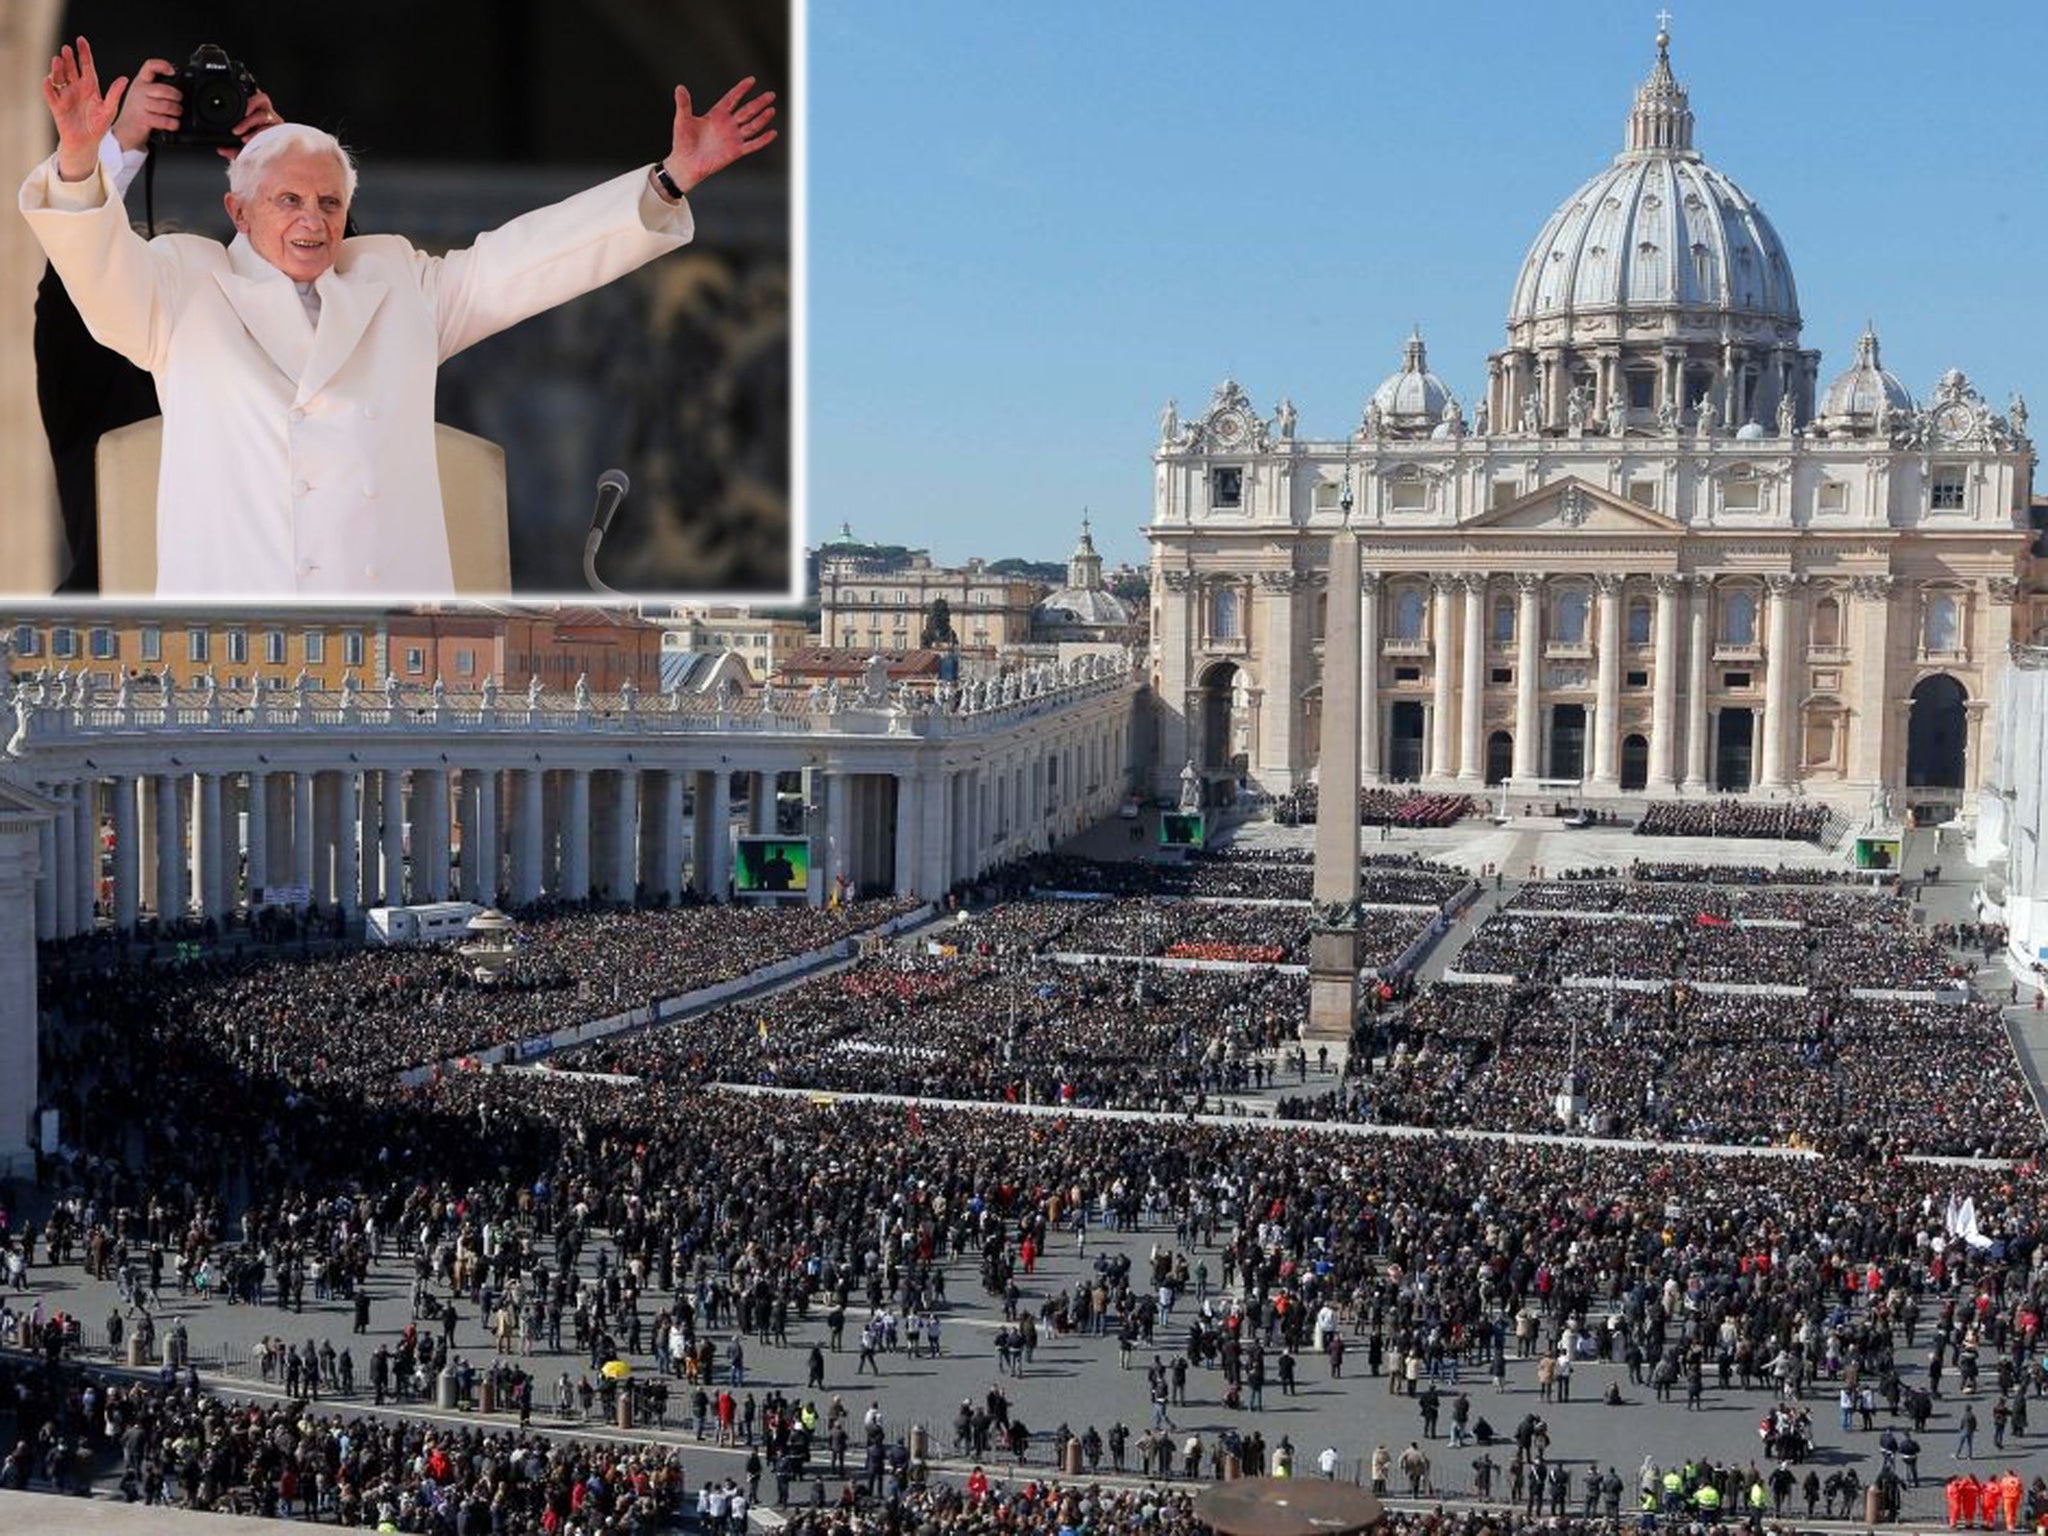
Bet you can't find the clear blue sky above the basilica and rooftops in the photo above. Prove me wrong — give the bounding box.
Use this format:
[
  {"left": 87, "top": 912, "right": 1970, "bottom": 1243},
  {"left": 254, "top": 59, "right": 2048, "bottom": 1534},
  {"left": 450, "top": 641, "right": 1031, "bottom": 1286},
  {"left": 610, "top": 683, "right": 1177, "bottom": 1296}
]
[{"left": 809, "top": 0, "right": 2048, "bottom": 561}]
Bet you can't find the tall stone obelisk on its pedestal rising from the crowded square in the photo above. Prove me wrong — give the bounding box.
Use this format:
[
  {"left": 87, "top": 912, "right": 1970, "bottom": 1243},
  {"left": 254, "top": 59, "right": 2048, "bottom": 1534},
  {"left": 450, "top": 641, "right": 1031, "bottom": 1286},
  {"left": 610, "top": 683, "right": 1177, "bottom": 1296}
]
[{"left": 1305, "top": 475, "right": 1360, "bottom": 1040}]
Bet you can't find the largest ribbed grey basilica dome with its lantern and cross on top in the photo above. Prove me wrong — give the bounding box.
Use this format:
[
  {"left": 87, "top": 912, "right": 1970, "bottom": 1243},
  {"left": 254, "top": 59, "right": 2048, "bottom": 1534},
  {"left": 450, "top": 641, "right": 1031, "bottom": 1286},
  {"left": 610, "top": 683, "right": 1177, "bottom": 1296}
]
[{"left": 1507, "top": 33, "right": 1798, "bottom": 332}]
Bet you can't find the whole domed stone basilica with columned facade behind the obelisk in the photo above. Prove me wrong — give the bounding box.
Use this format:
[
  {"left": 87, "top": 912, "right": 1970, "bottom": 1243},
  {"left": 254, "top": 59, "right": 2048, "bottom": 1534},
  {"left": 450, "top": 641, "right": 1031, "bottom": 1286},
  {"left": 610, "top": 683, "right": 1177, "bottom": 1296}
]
[{"left": 1147, "top": 35, "right": 2048, "bottom": 809}]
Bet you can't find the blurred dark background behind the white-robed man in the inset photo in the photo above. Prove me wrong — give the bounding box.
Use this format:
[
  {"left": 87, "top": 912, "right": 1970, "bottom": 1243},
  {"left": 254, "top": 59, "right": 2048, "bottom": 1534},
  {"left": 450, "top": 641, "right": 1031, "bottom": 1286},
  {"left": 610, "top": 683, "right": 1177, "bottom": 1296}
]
[{"left": 66, "top": 0, "right": 801, "bottom": 594}]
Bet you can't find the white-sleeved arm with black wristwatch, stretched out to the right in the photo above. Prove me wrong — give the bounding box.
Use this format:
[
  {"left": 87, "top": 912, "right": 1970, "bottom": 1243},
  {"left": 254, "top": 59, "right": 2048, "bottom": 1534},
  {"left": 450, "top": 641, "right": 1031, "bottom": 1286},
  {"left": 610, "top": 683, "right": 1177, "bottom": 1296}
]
[{"left": 418, "top": 78, "right": 776, "bottom": 358}]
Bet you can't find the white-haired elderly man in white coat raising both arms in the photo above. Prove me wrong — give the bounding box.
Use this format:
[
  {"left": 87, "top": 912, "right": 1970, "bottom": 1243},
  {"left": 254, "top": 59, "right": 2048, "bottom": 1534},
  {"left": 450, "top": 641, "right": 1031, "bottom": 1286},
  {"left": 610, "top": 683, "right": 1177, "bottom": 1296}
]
[{"left": 20, "top": 39, "right": 776, "bottom": 602}]
